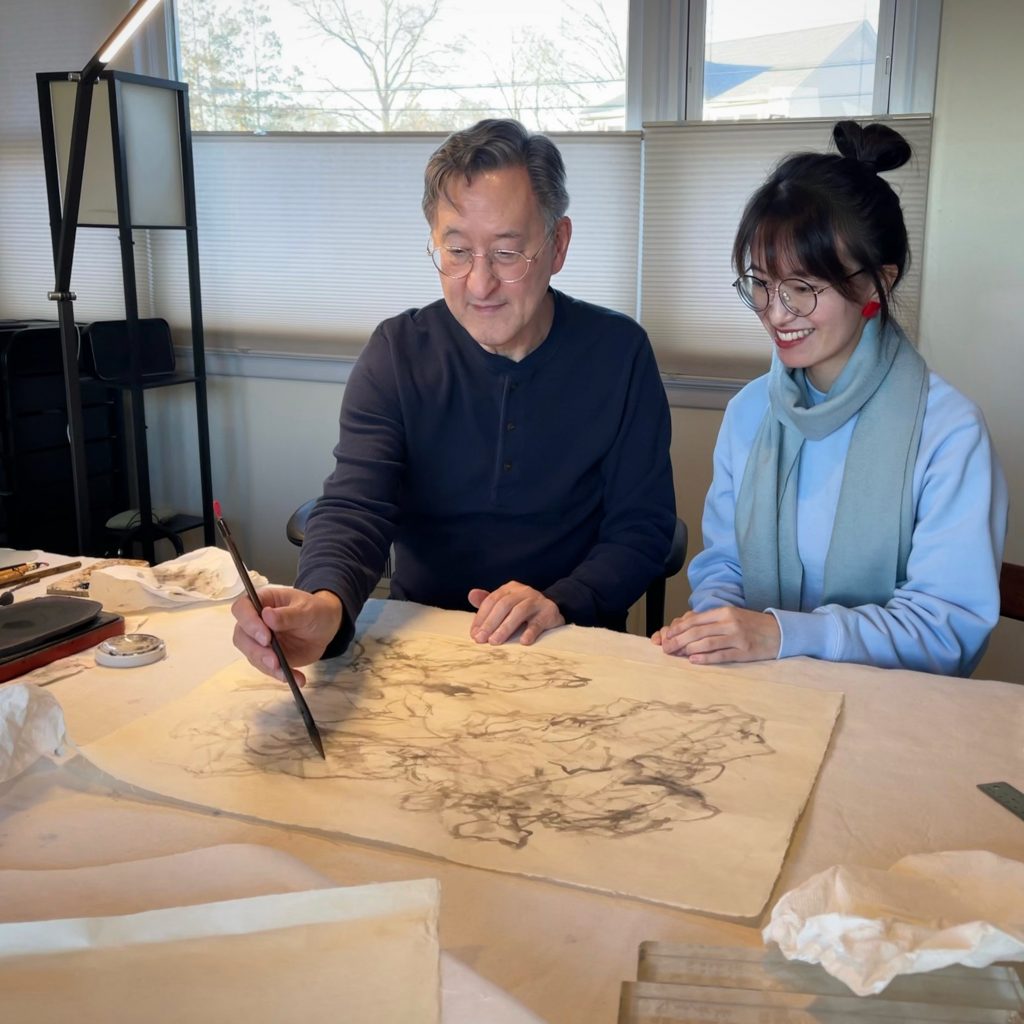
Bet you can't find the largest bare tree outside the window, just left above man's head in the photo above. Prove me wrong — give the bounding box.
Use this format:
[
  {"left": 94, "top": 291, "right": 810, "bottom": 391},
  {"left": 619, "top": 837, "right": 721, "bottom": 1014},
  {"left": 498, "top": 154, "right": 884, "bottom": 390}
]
[{"left": 291, "top": 0, "right": 458, "bottom": 131}]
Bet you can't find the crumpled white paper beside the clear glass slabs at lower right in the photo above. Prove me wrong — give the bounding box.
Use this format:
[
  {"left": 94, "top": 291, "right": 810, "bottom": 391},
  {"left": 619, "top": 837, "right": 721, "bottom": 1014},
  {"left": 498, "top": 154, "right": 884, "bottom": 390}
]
[{"left": 762, "top": 850, "right": 1024, "bottom": 995}]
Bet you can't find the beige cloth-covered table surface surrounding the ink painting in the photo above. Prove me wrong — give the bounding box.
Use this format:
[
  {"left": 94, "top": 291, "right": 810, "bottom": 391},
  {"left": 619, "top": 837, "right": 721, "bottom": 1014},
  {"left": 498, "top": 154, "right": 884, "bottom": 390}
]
[{"left": 0, "top": 553, "right": 1024, "bottom": 1024}]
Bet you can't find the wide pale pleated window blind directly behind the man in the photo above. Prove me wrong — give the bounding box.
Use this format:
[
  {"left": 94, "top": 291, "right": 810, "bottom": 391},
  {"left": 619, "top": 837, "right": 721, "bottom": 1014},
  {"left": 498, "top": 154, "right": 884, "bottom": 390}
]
[{"left": 151, "top": 134, "right": 641, "bottom": 355}]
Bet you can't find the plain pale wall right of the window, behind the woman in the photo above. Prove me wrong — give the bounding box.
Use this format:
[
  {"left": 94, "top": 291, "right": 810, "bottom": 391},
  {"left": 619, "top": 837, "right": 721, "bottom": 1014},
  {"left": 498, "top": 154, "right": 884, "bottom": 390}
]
[{"left": 921, "top": 0, "right": 1024, "bottom": 682}]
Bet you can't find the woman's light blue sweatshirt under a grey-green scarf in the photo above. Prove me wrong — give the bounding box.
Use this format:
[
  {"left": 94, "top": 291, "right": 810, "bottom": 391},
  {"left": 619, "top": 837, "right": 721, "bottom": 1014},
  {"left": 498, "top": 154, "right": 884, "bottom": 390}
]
[{"left": 689, "top": 373, "right": 1008, "bottom": 676}]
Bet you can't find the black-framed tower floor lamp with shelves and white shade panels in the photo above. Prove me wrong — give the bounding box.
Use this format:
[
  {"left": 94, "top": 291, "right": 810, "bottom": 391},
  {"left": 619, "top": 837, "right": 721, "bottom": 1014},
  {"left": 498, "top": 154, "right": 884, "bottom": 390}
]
[{"left": 34, "top": 69, "right": 216, "bottom": 562}]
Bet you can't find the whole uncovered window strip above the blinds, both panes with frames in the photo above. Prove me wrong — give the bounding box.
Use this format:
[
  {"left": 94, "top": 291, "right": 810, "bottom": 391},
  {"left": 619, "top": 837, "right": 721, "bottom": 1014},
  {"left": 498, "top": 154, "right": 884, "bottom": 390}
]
[{"left": 177, "top": 0, "right": 940, "bottom": 134}]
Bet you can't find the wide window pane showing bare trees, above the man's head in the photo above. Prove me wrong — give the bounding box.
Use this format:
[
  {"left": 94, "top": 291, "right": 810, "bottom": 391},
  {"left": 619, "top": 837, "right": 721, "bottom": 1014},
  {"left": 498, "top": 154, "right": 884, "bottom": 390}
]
[{"left": 178, "top": 0, "right": 629, "bottom": 133}]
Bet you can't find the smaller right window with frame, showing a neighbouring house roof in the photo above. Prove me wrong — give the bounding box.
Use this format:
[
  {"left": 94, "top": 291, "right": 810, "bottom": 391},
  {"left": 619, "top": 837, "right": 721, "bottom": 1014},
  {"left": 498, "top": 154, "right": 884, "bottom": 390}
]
[{"left": 626, "top": 0, "right": 941, "bottom": 128}]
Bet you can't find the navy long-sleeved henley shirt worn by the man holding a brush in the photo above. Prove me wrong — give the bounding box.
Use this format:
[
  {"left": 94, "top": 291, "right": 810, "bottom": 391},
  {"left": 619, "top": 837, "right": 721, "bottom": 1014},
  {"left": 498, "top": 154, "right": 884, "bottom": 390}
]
[{"left": 295, "top": 289, "right": 675, "bottom": 654}]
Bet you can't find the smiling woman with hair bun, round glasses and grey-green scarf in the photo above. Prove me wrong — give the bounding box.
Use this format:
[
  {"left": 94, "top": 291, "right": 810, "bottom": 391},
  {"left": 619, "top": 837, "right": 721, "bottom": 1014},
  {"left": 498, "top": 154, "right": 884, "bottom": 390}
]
[{"left": 652, "top": 121, "right": 1007, "bottom": 676}]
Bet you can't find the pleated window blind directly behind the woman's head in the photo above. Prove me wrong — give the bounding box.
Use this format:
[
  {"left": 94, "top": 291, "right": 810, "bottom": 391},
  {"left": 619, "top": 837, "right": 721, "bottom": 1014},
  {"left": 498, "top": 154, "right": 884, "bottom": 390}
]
[{"left": 640, "top": 117, "right": 932, "bottom": 379}]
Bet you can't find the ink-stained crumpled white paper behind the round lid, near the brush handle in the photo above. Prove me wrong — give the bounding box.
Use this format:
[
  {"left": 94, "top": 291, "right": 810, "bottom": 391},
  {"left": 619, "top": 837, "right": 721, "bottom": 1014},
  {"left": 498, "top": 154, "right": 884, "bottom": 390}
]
[{"left": 89, "top": 548, "right": 267, "bottom": 612}]
